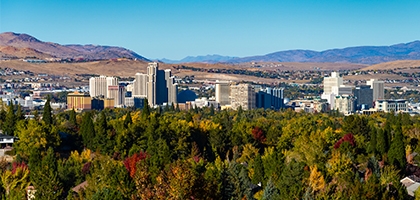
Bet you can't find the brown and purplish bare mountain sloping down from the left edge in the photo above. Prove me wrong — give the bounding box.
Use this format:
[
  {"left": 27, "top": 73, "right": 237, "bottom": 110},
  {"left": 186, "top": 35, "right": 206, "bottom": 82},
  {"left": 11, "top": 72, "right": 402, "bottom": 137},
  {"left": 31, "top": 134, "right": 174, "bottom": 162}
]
[{"left": 0, "top": 32, "right": 150, "bottom": 61}]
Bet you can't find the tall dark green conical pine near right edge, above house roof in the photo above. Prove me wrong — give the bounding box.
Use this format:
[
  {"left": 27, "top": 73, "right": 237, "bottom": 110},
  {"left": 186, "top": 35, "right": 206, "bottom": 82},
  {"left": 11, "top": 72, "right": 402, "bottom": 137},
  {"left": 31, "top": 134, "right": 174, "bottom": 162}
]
[{"left": 388, "top": 123, "right": 407, "bottom": 171}]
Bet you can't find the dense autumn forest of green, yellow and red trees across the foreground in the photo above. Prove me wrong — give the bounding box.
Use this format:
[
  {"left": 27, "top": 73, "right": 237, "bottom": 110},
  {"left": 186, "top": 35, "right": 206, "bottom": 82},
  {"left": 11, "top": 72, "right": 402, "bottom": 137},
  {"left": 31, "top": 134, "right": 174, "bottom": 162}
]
[{"left": 0, "top": 96, "right": 420, "bottom": 200}]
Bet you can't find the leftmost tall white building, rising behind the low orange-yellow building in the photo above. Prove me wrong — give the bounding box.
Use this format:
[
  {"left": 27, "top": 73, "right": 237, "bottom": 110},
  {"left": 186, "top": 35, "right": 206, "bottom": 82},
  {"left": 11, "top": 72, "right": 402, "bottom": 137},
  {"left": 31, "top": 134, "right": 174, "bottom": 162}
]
[{"left": 89, "top": 76, "right": 118, "bottom": 98}]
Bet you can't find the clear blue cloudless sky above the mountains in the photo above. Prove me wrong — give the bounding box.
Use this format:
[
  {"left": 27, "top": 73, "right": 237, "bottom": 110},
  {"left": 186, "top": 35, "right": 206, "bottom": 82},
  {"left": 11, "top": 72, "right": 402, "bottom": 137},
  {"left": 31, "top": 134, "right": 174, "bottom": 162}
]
[{"left": 0, "top": 0, "right": 420, "bottom": 59}]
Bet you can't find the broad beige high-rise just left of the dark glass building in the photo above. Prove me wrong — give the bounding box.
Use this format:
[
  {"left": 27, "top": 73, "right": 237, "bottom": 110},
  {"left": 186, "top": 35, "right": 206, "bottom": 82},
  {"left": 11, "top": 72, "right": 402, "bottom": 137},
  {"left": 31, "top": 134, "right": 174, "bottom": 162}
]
[{"left": 230, "top": 84, "right": 256, "bottom": 110}]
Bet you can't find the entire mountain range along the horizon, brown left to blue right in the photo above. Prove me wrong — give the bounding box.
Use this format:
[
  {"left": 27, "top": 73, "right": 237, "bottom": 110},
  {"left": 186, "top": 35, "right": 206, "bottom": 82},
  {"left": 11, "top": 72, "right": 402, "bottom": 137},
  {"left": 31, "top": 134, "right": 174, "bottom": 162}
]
[{"left": 0, "top": 32, "right": 420, "bottom": 65}]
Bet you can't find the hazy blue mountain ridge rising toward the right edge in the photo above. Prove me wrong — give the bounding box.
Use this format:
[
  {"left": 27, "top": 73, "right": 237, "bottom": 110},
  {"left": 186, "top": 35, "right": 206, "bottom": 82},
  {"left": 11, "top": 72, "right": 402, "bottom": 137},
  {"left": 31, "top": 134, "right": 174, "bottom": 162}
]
[{"left": 226, "top": 41, "right": 420, "bottom": 64}]
